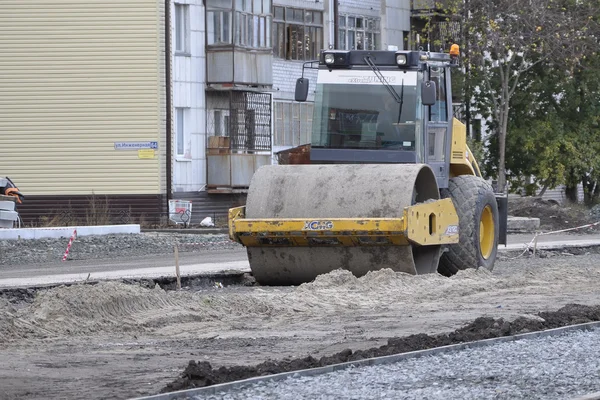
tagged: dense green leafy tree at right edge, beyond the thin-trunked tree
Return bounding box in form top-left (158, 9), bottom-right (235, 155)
top-left (506, 51), bottom-right (600, 203)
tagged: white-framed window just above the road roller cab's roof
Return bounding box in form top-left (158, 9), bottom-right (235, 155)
top-left (338, 15), bottom-right (381, 50)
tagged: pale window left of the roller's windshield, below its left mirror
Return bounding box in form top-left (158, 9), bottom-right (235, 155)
top-left (273, 101), bottom-right (313, 146)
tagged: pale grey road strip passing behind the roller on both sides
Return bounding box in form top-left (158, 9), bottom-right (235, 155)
top-left (0, 234), bottom-right (600, 287)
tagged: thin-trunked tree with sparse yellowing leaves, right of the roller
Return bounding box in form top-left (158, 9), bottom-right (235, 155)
top-left (463, 0), bottom-right (598, 191)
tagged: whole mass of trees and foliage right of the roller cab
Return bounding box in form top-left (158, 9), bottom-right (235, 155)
top-left (414, 0), bottom-right (600, 203)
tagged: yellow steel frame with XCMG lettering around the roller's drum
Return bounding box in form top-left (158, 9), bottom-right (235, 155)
top-left (229, 199), bottom-right (459, 247)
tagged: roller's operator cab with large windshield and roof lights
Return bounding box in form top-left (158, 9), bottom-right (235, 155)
top-left (296, 51), bottom-right (479, 188)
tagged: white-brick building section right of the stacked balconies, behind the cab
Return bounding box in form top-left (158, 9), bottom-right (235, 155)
top-left (273, 0), bottom-right (410, 155)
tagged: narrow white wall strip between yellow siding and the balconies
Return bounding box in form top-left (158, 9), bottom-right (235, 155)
top-left (171, 0), bottom-right (206, 192)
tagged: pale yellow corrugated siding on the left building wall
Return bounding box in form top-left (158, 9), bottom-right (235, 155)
top-left (0, 0), bottom-right (165, 195)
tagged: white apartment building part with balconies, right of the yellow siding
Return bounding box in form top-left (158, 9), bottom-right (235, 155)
top-left (172, 0), bottom-right (411, 220)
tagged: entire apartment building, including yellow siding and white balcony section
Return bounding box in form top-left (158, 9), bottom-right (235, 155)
top-left (0, 0), bottom-right (446, 222)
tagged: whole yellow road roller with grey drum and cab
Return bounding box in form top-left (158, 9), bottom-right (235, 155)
top-left (229, 46), bottom-right (507, 285)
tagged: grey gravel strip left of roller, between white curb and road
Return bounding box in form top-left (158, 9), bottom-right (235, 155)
top-left (0, 232), bottom-right (241, 265)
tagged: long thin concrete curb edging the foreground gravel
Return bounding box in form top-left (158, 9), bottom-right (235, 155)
top-left (134, 322), bottom-right (600, 400)
